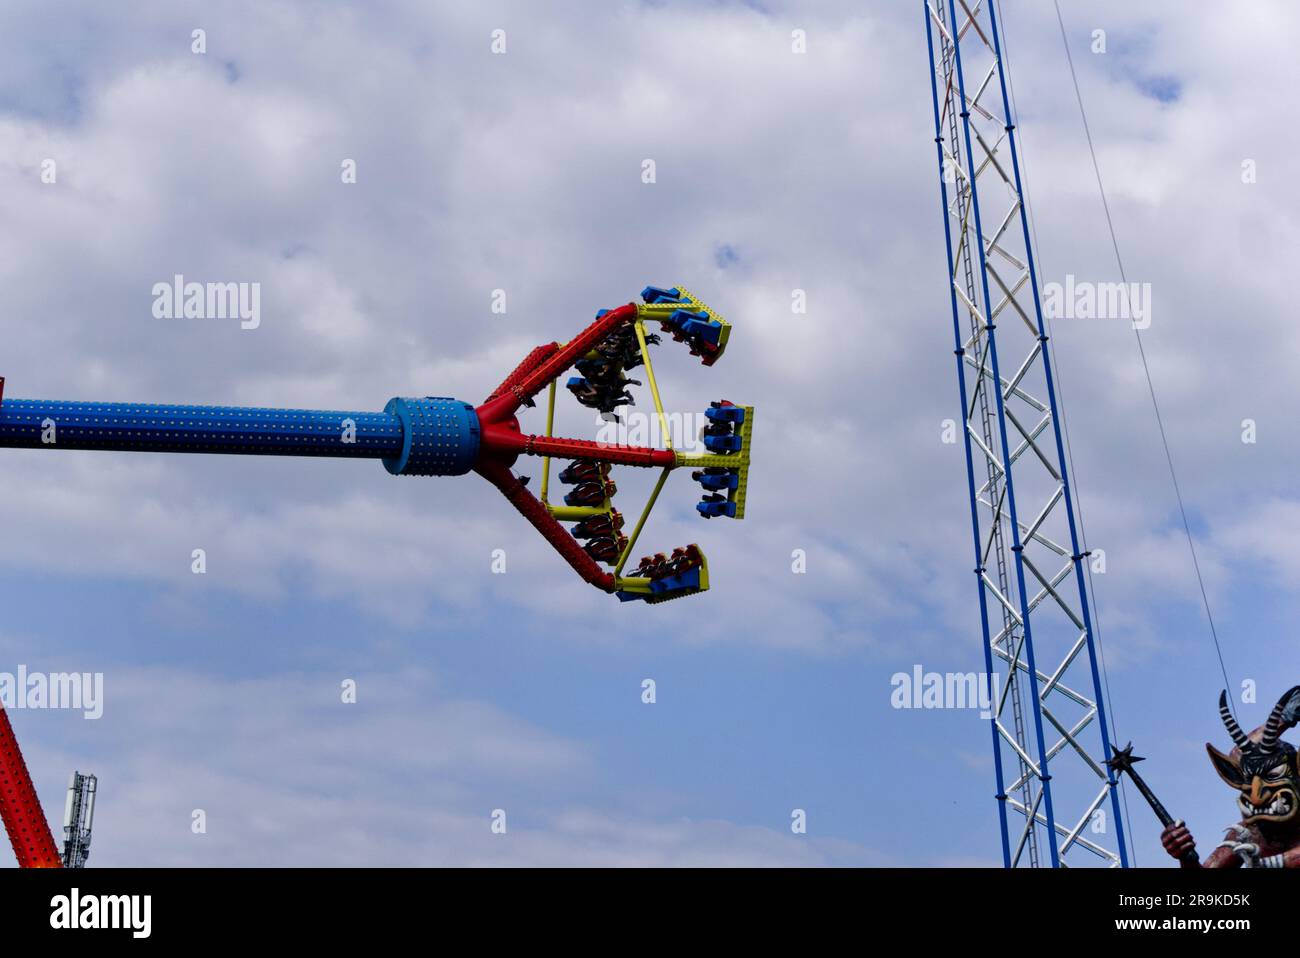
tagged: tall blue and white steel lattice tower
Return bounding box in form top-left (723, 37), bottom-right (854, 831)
top-left (923, 0), bottom-right (1128, 867)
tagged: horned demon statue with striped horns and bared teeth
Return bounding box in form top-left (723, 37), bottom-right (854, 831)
top-left (1160, 685), bottom-right (1300, 868)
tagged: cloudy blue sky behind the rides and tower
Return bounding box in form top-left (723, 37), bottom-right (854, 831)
top-left (0, 0), bottom-right (1300, 866)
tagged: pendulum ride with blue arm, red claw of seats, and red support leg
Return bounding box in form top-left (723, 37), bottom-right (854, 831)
top-left (0, 286), bottom-right (754, 867)
